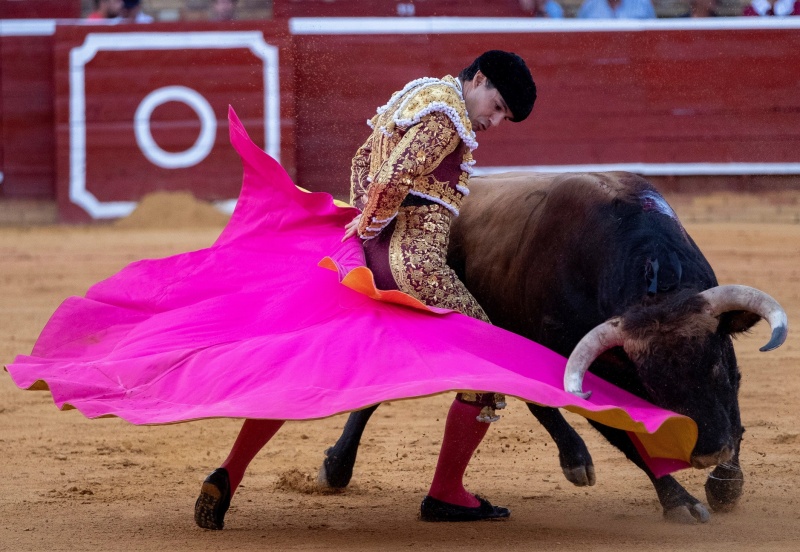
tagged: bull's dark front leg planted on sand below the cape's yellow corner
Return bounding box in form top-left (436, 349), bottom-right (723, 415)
top-left (589, 420), bottom-right (711, 523)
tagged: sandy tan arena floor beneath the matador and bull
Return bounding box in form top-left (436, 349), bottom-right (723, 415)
top-left (0, 194), bottom-right (800, 552)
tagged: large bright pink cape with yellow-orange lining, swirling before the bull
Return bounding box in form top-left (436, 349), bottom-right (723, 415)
top-left (6, 106), bottom-right (697, 475)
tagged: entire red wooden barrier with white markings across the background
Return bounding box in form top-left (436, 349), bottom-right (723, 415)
top-left (0, 17), bottom-right (800, 221)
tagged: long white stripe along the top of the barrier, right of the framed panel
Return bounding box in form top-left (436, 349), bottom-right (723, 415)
top-left (289, 17), bottom-right (800, 35)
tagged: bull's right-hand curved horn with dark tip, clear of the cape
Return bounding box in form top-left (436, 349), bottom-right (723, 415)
top-left (700, 285), bottom-right (789, 351)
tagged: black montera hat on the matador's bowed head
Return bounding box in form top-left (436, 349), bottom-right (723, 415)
top-left (478, 50), bottom-right (536, 123)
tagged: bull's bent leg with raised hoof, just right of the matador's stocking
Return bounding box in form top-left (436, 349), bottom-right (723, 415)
top-left (527, 403), bottom-right (595, 487)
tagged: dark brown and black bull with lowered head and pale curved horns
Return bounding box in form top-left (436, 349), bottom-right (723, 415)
top-left (320, 172), bottom-right (787, 523)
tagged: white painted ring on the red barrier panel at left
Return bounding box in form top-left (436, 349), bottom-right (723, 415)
top-left (133, 86), bottom-right (217, 169)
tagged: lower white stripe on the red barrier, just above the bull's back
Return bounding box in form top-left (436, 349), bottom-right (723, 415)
top-left (475, 163), bottom-right (800, 176)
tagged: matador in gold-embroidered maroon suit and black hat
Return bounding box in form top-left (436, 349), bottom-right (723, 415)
top-left (345, 50), bottom-right (536, 521)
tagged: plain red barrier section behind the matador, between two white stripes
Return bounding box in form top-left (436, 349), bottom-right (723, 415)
top-left (294, 25), bottom-right (800, 198)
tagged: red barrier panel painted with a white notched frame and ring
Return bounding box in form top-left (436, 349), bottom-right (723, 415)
top-left (55, 22), bottom-right (296, 221)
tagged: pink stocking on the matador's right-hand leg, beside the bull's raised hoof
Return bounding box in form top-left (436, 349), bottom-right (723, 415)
top-left (428, 400), bottom-right (489, 508)
